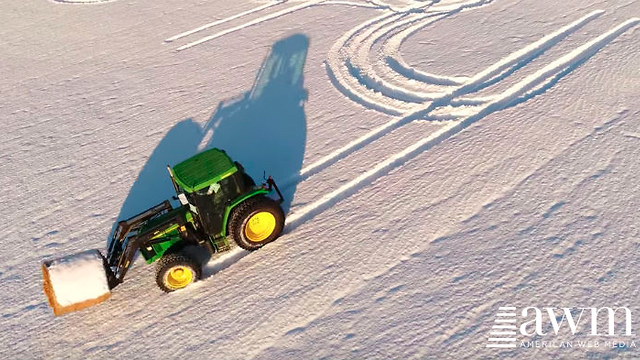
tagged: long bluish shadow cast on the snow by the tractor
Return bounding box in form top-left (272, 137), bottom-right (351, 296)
top-left (112, 34), bottom-right (309, 275)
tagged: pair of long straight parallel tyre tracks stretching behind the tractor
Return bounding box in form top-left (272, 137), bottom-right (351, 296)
top-left (287, 10), bottom-right (640, 229)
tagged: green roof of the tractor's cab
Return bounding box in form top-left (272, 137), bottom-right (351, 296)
top-left (171, 148), bottom-right (238, 192)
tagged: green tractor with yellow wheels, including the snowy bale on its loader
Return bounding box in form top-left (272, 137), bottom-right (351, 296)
top-left (43, 149), bottom-right (285, 314)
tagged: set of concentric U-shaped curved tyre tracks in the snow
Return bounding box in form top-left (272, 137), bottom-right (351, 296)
top-left (326, 0), bottom-right (491, 116)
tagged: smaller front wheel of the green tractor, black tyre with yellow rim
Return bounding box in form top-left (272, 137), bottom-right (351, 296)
top-left (156, 252), bottom-right (202, 292)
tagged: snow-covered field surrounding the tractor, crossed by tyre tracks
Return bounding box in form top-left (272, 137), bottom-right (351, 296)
top-left (0, 0), bottom-right (640, 359)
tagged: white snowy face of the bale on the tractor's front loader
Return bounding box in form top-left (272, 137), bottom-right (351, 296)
top-left (47, 250), bottom-right (109, 306)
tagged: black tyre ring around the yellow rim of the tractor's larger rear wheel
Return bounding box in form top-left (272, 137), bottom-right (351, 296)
top-left (229, 196), bottom-right (284, 251)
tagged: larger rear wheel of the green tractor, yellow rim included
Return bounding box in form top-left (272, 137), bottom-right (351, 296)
top-left (229, 196), bottom-right (284, 251)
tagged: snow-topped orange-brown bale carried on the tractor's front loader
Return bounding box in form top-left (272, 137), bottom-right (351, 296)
top-left (42, 250), bottom-right (111, 316)
